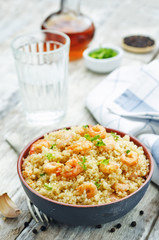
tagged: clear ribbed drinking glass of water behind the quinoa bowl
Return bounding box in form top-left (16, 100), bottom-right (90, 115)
top-left (11, 30), bottom-right (70, 125)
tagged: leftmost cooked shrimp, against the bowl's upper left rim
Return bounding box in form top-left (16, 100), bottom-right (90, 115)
top-left (29, 139), bottom-right (50, 154)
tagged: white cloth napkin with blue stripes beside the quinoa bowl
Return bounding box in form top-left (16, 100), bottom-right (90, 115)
top-left (86, 60), bottom-right (159, 185)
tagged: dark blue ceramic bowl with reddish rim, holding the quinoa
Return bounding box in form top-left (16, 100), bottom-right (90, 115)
top-left (17, 128), bottom-right (153, 226)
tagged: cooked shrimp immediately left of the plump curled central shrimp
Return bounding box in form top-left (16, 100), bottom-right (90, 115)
top-left (43, 162), bottom-right (63, 176)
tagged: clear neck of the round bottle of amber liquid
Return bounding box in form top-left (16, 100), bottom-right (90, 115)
top-left (61, 0), bottom-right (80, 15)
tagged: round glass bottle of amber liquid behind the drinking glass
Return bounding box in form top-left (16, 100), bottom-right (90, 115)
top-left (41, 0), bottom-right (95, 61)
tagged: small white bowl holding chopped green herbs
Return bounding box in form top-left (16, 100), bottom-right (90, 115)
top-left (83, 44), bottom-right (123, 73)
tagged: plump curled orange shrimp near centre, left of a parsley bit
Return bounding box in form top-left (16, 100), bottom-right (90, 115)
top-left (62, 158), bottom-right (83, 178)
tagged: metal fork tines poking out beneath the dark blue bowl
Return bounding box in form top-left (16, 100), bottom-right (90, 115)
top-left (26, 198), bottom-right (51, 227)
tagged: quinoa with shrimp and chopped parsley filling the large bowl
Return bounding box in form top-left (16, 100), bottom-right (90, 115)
top-left (22, 125), bottom-right (149, 205)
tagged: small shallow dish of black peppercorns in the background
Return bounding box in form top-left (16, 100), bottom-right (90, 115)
top-left (122, 35), bottom-right (155, 53)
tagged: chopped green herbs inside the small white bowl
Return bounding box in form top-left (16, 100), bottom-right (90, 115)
top-left (89, 48), bottom-right (118, 59)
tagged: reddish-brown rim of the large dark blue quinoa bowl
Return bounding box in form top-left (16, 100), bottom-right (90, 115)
top-left (17, 127), bottom-right (154, 208)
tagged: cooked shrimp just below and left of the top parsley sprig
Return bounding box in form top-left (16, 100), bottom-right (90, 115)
top-left (67, 141), bottom-right (93, 154)
